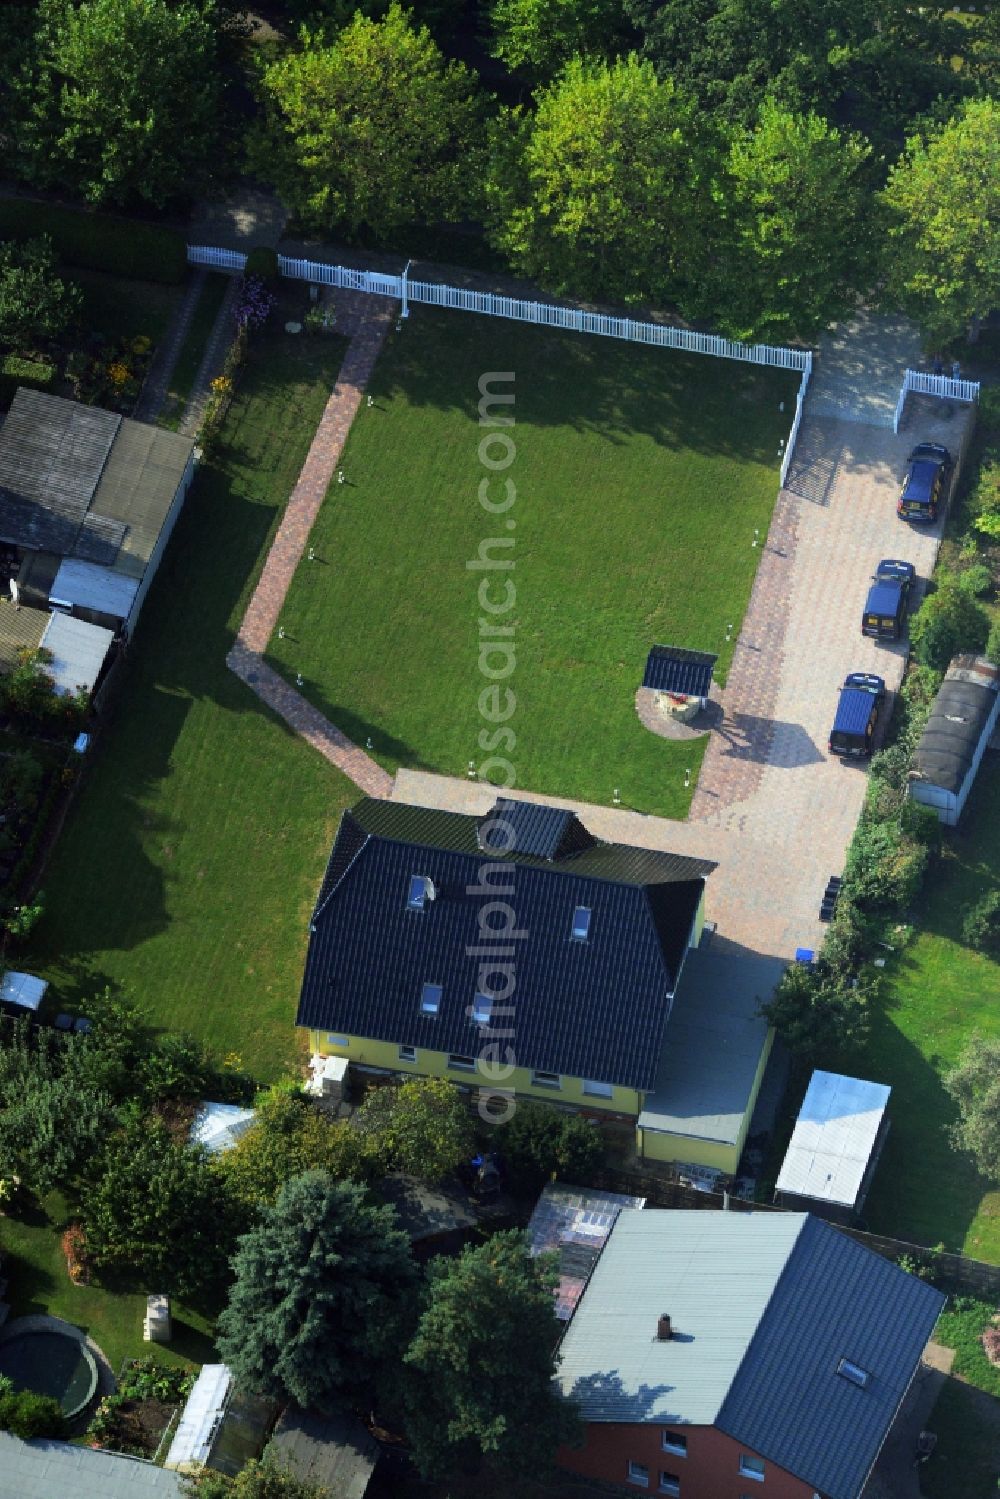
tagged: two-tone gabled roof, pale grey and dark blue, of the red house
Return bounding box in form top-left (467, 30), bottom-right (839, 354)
top-left (559, 1210), bottom-right (945, 1499)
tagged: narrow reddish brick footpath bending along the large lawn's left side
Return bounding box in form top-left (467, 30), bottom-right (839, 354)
top-left (226, 291), bottom-right (396, 796)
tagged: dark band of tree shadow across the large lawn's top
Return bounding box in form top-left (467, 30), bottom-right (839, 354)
top-left (370, 307), bottom-right (801, 461)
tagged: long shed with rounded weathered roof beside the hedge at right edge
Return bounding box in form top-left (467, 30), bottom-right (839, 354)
top-left (910, 655), bottom-right (1000, 827)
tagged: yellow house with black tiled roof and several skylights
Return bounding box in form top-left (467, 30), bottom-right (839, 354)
top-left (298, 797), bottom-right (763, 1171)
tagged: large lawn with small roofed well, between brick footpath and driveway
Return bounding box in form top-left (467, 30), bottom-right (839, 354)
top-left (270, 307), bottom-right (798, 817)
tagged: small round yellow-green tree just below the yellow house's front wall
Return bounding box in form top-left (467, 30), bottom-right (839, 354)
top-left (354, 1078), bottom-right (475, 1181)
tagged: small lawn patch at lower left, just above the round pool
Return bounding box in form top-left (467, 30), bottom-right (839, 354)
top-left (0, 1193), bottom-right (211, 1373)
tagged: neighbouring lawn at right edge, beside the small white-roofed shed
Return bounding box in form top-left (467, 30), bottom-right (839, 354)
top-left (855, 755), bottom-right (1000, 1264)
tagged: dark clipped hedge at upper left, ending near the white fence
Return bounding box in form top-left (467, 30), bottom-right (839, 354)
top-left (0, 198), bottom-right (187, 285)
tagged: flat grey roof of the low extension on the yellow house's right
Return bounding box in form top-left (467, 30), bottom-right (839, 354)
top-left (639, 934), bottom-right (786, 1145)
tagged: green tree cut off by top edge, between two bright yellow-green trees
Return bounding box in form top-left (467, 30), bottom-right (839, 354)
top-left (489, 0), bottom-right (628, 81)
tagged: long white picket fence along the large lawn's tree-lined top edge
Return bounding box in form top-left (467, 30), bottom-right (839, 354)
top-left (187, 244), bottom-right (813, 370)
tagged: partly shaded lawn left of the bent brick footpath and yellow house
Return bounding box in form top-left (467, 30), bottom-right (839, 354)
top-left (19, 313), bottom-right (354, 1079)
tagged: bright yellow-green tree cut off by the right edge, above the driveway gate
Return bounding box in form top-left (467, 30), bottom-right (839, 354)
top-left (883, 99), bottom-right (1000, 343)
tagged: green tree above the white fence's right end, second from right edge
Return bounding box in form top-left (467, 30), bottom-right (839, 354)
top-left (701, 103), bottom-right (871, 342)
